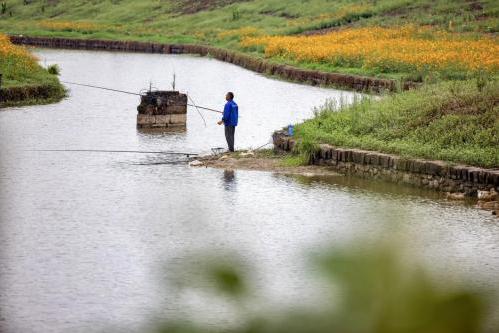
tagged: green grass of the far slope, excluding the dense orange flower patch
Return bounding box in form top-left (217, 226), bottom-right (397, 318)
top-left (0, 0), bottom-right (499, 80)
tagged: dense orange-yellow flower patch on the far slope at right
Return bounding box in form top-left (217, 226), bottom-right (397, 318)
top-left (241, 26), bottom-right (499, 72)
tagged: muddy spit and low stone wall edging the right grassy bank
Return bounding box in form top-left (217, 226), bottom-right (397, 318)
top-left (190, 149), bottom-right (499, 216)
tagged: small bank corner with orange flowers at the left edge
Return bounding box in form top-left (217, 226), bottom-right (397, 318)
top-left (0, 34), bottom-right (65, 106)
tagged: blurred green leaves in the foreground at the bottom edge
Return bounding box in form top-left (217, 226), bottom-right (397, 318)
top-left (157, 237), bottom-right (490, 333)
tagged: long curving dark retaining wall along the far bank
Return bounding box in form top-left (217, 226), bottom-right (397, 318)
top-left (10, 36), bottom-right (417, 92)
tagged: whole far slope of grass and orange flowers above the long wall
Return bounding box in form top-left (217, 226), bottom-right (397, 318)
top-left (0, 0), bottom-right (499, 81)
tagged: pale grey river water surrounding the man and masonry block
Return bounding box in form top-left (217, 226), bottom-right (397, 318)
top-left (0, 50), bottom-right (499, 332)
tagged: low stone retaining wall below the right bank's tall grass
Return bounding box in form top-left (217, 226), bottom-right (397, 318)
top-left (273, 131), bottom-right (499, 197)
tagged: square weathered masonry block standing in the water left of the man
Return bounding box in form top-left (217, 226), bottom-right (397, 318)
top-left (137, 91), bottom-right (187, 128)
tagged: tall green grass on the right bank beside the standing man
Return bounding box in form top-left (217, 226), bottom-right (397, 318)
top-left (296, 80), bottom-right (499, 167)
